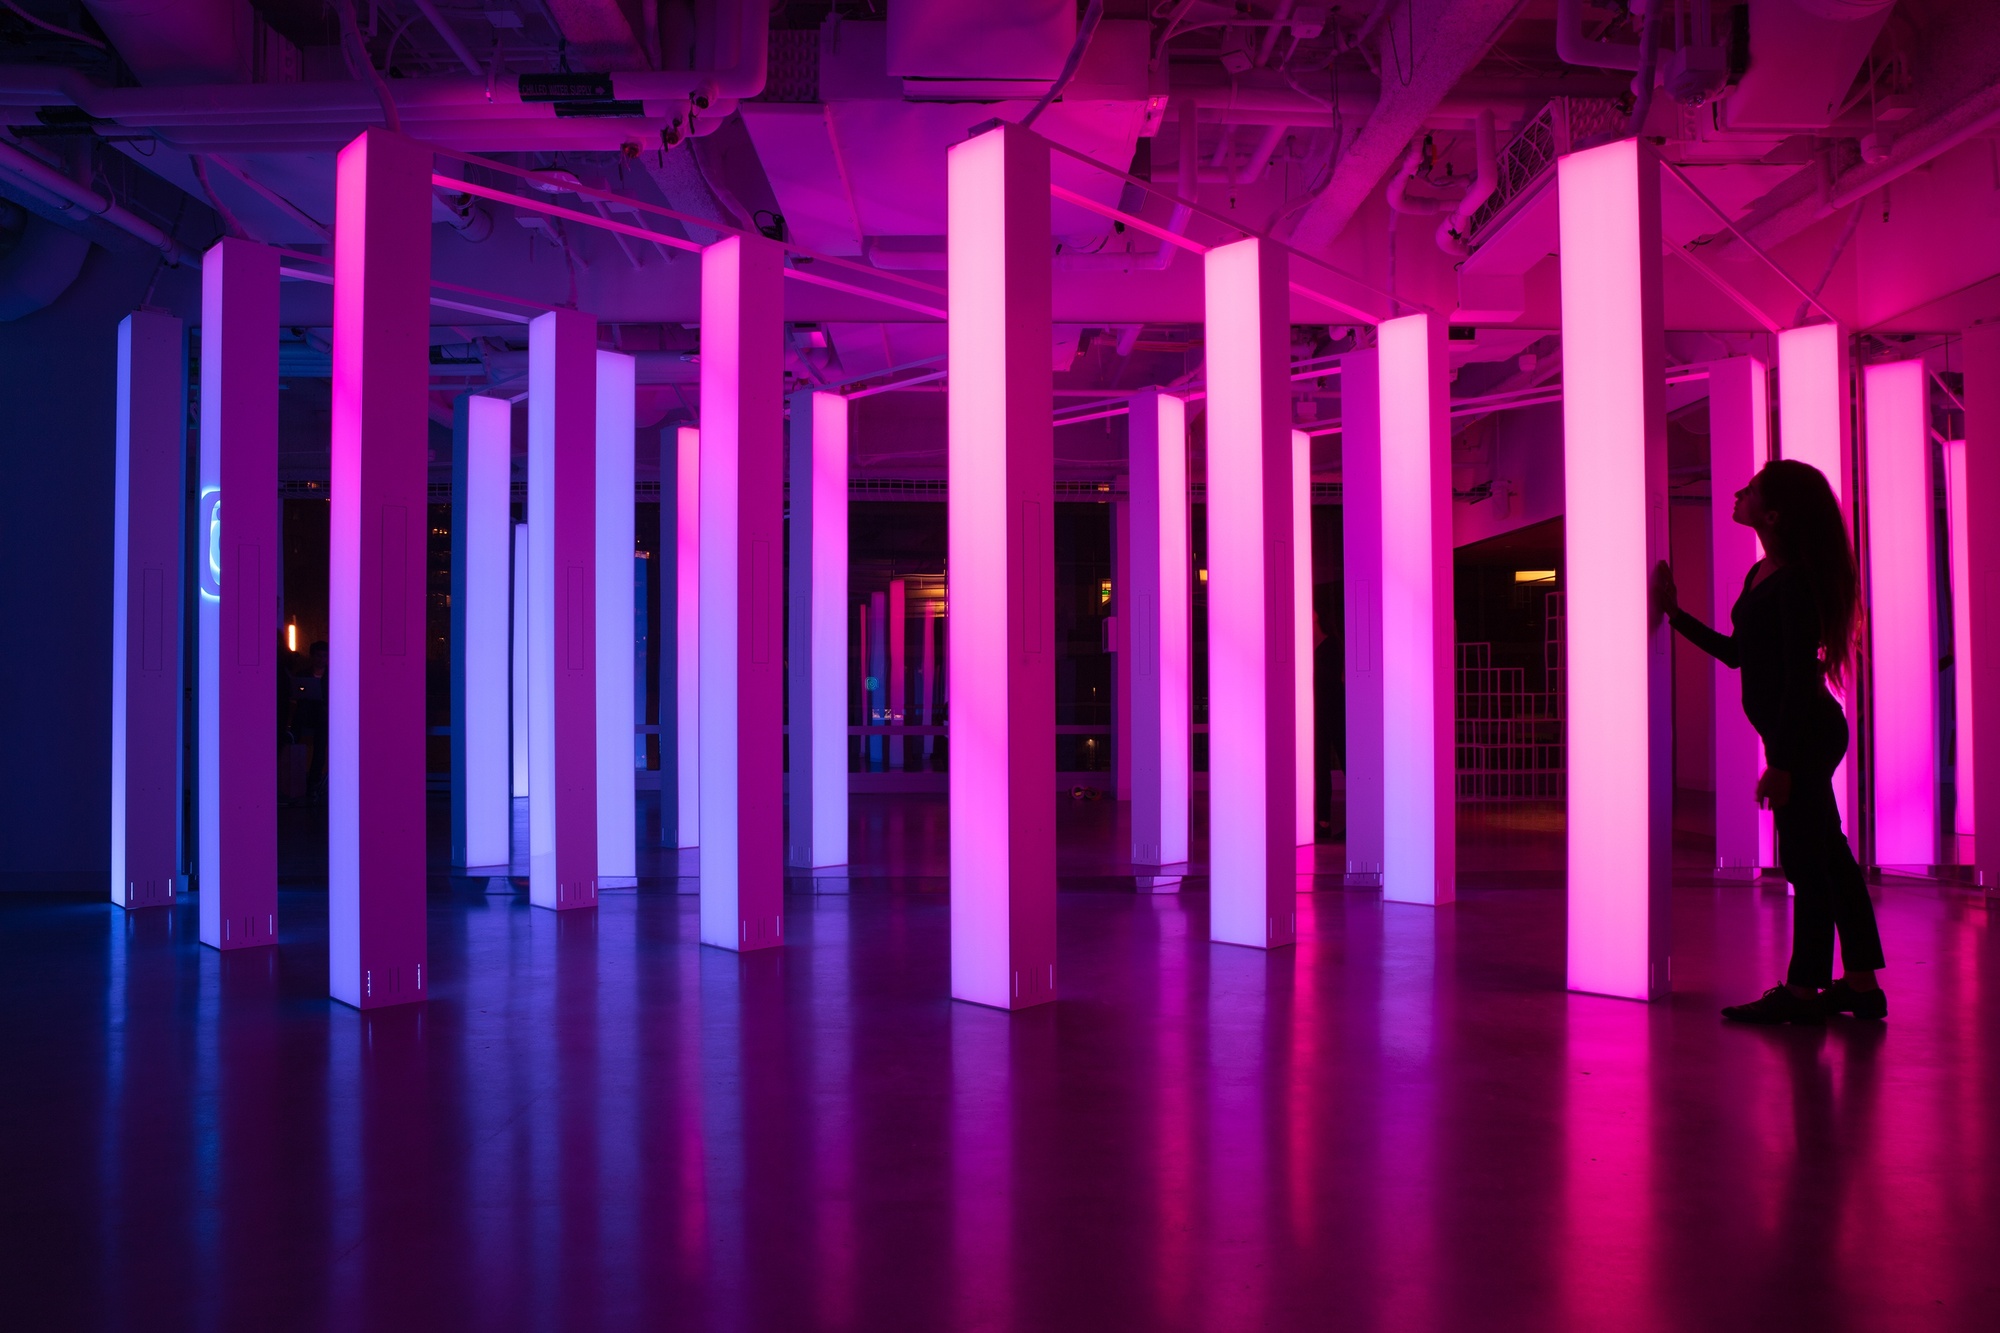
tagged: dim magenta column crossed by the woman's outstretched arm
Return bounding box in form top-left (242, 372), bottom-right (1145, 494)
top-left (1708, 356), bottom-right (1770, 879)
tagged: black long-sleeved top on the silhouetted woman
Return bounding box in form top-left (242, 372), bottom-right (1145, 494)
top-left (1672, 564), bottom-right (1842, 771)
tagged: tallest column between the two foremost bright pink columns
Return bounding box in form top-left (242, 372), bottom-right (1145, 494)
top-left (1204, 238), bottom-right (1298, 949)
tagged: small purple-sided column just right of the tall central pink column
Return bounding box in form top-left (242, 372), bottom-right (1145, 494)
top-left (1118, 388), bottom-right (1192, 872)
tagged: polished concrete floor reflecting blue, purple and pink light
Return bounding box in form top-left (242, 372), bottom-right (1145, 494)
top-left (0, 797), bottom-right (2000, 1333)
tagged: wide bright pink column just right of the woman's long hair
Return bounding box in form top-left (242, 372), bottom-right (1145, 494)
top-left (1862, 360), bottom-right (1940, 867)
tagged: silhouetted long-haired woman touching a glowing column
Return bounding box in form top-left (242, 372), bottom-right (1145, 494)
top-left (1654, 460), bottom-right (1888, 1023)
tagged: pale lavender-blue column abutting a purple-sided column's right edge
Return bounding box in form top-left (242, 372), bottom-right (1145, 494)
top-left (596, 352), bottom-right (638, 887)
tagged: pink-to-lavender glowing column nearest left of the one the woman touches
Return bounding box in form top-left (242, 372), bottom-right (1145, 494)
top-left (1376, 314), bottom-right (1458, 907)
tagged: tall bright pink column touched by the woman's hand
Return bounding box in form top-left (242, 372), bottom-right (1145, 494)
top-left (1560, 140), bottom-right (1674, 999)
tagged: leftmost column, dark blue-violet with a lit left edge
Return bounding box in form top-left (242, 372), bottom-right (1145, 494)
top-left (112, 310), bottom-right (185, 907)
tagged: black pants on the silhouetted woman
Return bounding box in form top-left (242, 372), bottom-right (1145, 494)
top-left (1776, 713), bottom-right (1882, 987)
